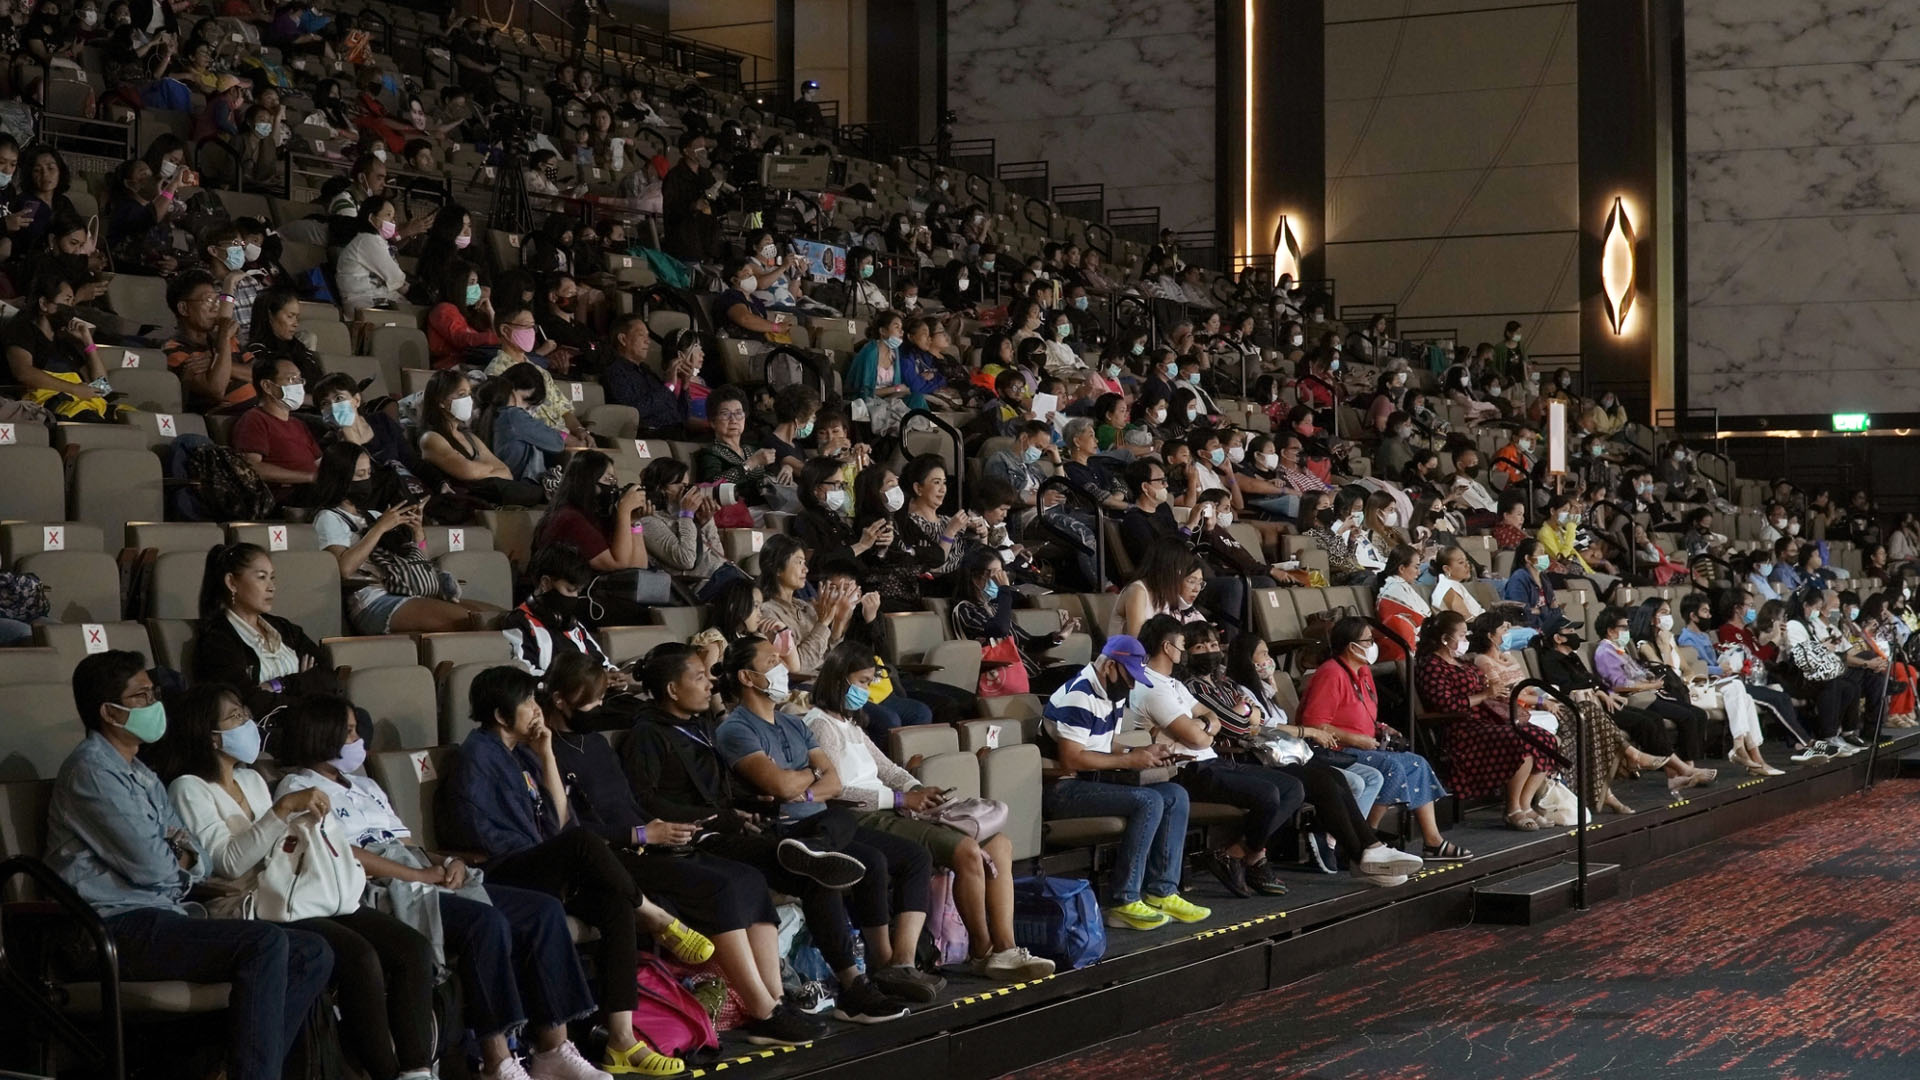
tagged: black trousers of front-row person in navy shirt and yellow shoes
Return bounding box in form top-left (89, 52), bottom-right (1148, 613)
top-left (486, 828), bottom-right (641, 1013)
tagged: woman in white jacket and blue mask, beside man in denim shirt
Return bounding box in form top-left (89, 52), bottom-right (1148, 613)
top-left (142, 684), bottom-right (434, 1080)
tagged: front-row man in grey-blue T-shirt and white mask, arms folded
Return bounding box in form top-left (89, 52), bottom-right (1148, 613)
top-left (714, 634), bottom-right (945, 999)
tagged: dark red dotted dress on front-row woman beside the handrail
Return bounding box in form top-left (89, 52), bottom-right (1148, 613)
top-left (1413, 655), bottom-right (1561, 799)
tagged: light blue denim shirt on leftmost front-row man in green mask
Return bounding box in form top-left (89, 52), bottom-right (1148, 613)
top-left (46, 732), bottom-right (207, 915)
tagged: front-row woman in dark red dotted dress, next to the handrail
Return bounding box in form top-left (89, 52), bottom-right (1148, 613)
top-left (1413, 611), bottom-right (1559, 832)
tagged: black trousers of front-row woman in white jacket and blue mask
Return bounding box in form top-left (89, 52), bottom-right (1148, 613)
top-left (290, 907), bottom-right (434, 1080)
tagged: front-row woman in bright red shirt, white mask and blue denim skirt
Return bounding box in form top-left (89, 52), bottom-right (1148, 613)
top-left (1298, 615), bottom-right (1473, 861)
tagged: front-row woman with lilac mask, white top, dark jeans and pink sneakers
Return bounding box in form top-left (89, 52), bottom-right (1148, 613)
top-left (273, 698), bottom-right (607, 1080)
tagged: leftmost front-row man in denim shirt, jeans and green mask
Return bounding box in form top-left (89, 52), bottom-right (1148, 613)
top-left (46, 650), bottom-right (334, 1080)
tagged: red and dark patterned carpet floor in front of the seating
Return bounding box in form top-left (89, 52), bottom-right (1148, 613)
top-left (1014, 780), bottom-right (1920, 1080)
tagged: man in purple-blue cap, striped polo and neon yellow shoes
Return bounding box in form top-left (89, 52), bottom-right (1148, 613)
top-left (1041, 634), bottom-right (1212, 930)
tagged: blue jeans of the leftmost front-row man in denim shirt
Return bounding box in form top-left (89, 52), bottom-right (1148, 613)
top-left (106, 907), bottom-right (334, 1080)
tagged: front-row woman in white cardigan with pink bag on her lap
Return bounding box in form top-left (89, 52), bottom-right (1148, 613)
top-left (806, 642), bottom-right (1054, 982)
